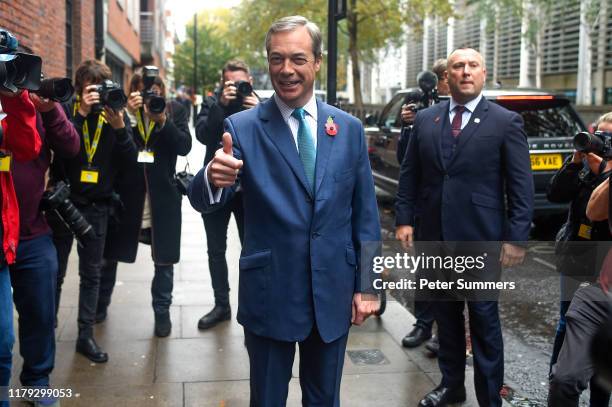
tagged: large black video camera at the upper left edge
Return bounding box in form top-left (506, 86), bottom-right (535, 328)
top-left (0, 28), bottom-right (42, 92)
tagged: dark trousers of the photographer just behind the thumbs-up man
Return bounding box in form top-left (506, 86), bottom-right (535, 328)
top-left (202, 192), bottom-right (244, 305)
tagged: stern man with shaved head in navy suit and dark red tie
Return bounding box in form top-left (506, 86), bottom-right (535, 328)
top-left (396, 48), bottom-right (533, 407)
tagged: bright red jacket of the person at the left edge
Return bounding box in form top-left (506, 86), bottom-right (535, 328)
top-left (0, 91), bottom-right (41, 264)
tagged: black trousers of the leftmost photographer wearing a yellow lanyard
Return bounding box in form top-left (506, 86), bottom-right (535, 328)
top-left (53, 203), bottom-right (108, 337)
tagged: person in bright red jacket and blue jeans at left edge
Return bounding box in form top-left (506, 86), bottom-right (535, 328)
top-left (0, 90), bottom-right (41, 407)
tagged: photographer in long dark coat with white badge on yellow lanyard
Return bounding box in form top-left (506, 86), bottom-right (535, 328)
top-left (97, 68), bottom-right (191, 337)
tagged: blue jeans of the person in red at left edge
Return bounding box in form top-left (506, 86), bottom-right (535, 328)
top-left (0, 265), bottom-right (15, 407)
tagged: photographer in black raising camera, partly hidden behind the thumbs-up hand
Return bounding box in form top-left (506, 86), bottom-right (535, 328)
top-left (196, 60), bottom-right (259, 329)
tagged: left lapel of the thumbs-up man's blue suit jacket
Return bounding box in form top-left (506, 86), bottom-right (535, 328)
top-left (259, 97), bottom-right (318, 198)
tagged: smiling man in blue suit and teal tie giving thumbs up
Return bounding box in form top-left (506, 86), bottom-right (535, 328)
top-left (189, 16), bottom-right (380, 407)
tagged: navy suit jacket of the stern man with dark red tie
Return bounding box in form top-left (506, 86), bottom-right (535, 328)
top-left (396, 97), bottom-right (534, 242)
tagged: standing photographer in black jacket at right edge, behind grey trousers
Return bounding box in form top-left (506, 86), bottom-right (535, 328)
top-left (547, 113), bottom-right (612, 406)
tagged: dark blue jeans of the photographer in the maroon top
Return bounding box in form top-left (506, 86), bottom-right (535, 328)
top-left (10, 235), bottom-right (57, 386)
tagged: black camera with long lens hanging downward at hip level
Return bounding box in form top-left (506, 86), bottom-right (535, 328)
top-left (40, 181), bottom-right (96, 244)
